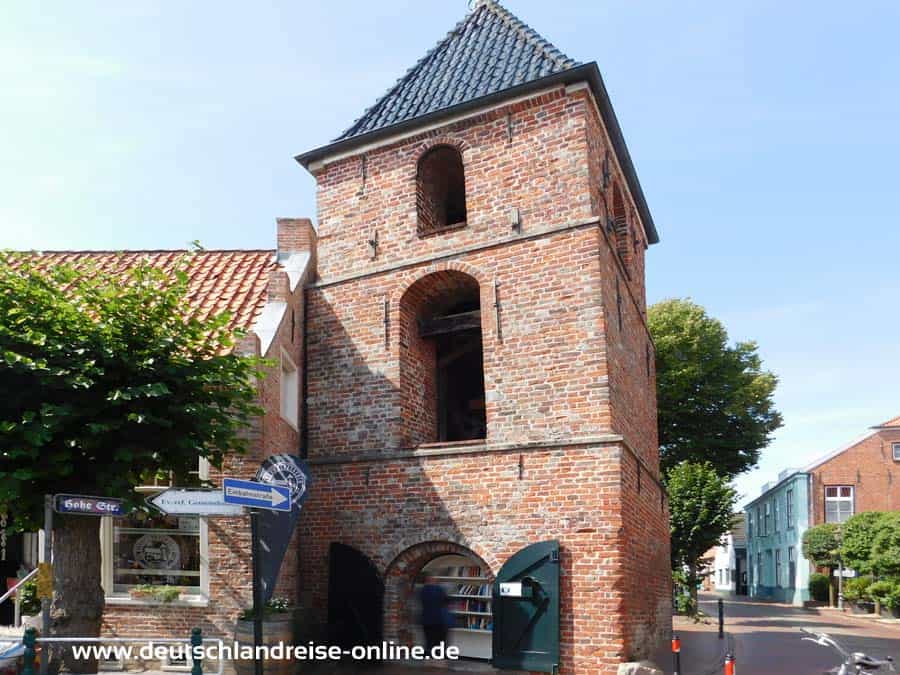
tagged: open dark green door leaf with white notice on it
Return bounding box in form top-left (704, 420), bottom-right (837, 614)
top-left (492, 541), bottom-right (559, 673)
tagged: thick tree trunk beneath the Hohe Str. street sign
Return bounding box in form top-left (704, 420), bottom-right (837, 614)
top-left (50, 515), bottom-right (103, 673)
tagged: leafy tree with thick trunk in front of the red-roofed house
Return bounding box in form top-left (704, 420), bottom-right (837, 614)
top-left (0, 253), bottom-right (261, 672)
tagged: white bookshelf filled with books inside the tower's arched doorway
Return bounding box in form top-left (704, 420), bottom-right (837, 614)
top-left (420, 555), bottom-right (493, 659)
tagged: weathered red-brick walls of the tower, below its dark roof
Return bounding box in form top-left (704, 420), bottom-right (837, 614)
top-left (301, 88), bottom-right (671, 673)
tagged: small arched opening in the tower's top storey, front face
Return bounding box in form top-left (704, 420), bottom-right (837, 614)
top-left (416, 145), bottom-right (467, 234)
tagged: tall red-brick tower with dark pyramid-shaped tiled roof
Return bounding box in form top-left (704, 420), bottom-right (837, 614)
top-left (297, 0), bottom-right (671, 674)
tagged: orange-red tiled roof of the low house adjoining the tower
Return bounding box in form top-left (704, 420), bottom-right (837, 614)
top-left (7, 250), bottom-right (278, 330)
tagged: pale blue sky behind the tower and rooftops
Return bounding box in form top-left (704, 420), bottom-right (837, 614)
top-left (0, 0), bottom-right (900, 502)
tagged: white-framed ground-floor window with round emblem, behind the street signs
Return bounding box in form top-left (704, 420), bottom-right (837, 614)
top-left (100, 459), bottom-right (209, 599)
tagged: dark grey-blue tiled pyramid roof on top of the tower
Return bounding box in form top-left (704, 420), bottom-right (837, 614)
top-left (335, 0), bottom-right (580, 141)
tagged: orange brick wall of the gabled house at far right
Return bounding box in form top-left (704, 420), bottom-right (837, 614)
top-left (810, 427), bottom-right (900, 525)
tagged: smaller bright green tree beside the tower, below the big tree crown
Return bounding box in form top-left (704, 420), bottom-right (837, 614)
top-left (666, 462), bottom-right (737, 612)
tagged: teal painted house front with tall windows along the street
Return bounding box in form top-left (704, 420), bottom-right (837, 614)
top-left (744, 469), bottom-right (810, 605)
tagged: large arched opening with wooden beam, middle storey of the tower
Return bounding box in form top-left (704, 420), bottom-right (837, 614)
top-left (400, 271), bottom-right (487, 446)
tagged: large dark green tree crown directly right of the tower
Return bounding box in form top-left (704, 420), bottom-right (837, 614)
top-left (647, 300), bottom-right (782, 478)
